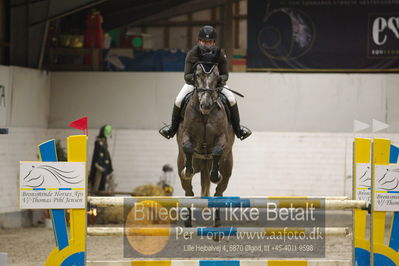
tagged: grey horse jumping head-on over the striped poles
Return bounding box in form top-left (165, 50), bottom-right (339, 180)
top-left (177, 64), bottom-right (235, 226)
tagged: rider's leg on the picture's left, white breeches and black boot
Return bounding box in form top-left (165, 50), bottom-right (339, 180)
top-left (159, 84), bottom-right (194, 139)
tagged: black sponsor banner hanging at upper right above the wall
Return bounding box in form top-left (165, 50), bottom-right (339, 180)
top-left (247, 0), bottom-right (399, 72)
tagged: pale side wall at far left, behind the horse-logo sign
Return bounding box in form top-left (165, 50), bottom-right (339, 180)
top-left (0, 67), bottom-right (50, 227)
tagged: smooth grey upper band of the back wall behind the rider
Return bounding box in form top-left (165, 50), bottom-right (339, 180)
top-left (49, 72), bottom-right (399, 133)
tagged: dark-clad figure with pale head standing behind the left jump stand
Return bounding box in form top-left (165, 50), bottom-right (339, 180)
top-left (89, 125), bottom-right (114, 194)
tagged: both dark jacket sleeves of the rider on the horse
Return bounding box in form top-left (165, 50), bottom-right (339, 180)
top-left (184, 44), bottom-right (229, 87)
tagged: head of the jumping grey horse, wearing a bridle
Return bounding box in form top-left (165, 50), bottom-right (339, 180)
top-left (194, 64), bottom-right (219, 115)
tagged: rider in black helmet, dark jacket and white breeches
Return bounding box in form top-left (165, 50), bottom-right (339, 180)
top-left (159, 26), bottom-right (252, 140)
